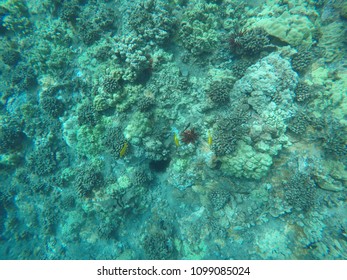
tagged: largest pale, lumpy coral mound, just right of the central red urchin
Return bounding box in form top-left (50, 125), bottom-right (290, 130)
top-left (217, 53), bottom-right (298, 179)
